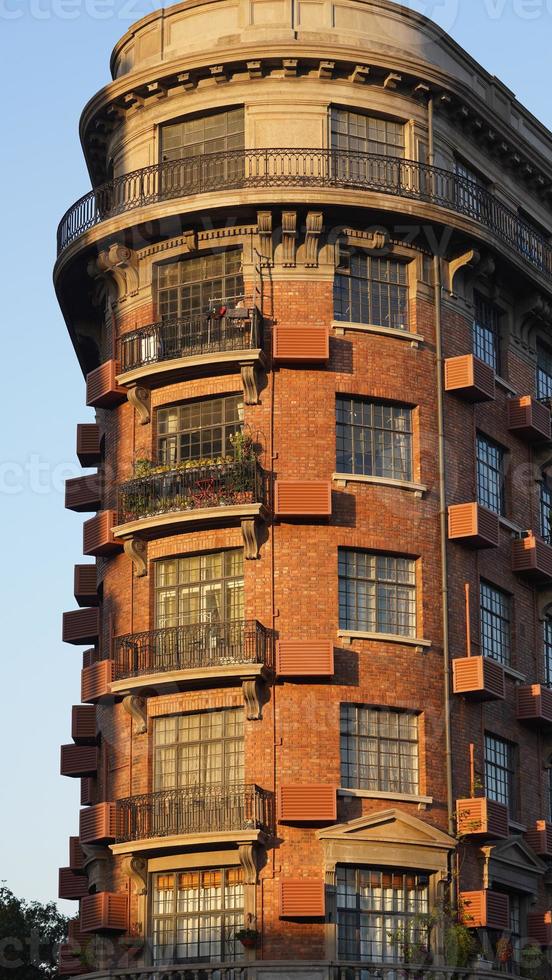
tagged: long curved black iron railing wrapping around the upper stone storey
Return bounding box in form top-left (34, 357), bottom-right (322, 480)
top-left (57, 148), bottom-right (552, 284)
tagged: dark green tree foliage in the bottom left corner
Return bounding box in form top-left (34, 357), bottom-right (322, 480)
top-left (0, 884), bottom-right (69, 980)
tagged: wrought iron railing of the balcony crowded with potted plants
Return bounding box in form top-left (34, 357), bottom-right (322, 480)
top-left (118, 460), bottom-right (266, 524)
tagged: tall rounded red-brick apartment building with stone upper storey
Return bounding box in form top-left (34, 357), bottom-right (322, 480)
top-left (55, 0), bottom-right (552, 980)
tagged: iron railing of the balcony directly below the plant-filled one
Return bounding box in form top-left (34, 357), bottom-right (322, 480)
top-left (113, 619), bottom-right (272, 680)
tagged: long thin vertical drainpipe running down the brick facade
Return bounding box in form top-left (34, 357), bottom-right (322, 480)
top-left (433, 255), bottom-right (455, 836)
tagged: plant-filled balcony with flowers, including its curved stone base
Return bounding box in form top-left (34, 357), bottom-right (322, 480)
top-left (113, 459), bottom-right (267, 558)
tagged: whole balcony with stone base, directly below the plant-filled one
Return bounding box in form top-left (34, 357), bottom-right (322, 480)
top-left (111, 620), bottom-right (273, 694)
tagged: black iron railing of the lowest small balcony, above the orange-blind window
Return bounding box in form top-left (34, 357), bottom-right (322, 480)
top-left (117, 784), bottom-right (274, 843)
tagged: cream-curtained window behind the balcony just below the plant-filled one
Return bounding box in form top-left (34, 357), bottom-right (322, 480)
top-left (155, 548), bottom-right (244, 629)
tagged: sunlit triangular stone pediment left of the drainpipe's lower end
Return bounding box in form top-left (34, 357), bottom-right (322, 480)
top-left (318, 809), bottom-right (456, 850)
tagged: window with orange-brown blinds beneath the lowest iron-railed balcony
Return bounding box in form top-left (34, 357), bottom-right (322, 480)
top-left (153, 868), bottom-right (244, 965)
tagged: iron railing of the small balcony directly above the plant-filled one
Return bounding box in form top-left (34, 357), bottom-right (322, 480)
top-left (119, 307), bottom-right (263, 373)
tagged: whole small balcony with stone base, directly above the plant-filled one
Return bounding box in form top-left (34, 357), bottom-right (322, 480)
top-left (118, 304), bottom-right (264, 396)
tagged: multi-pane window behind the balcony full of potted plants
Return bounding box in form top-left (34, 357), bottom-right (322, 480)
top-left (157, 395), bottom-right (243, 463)
